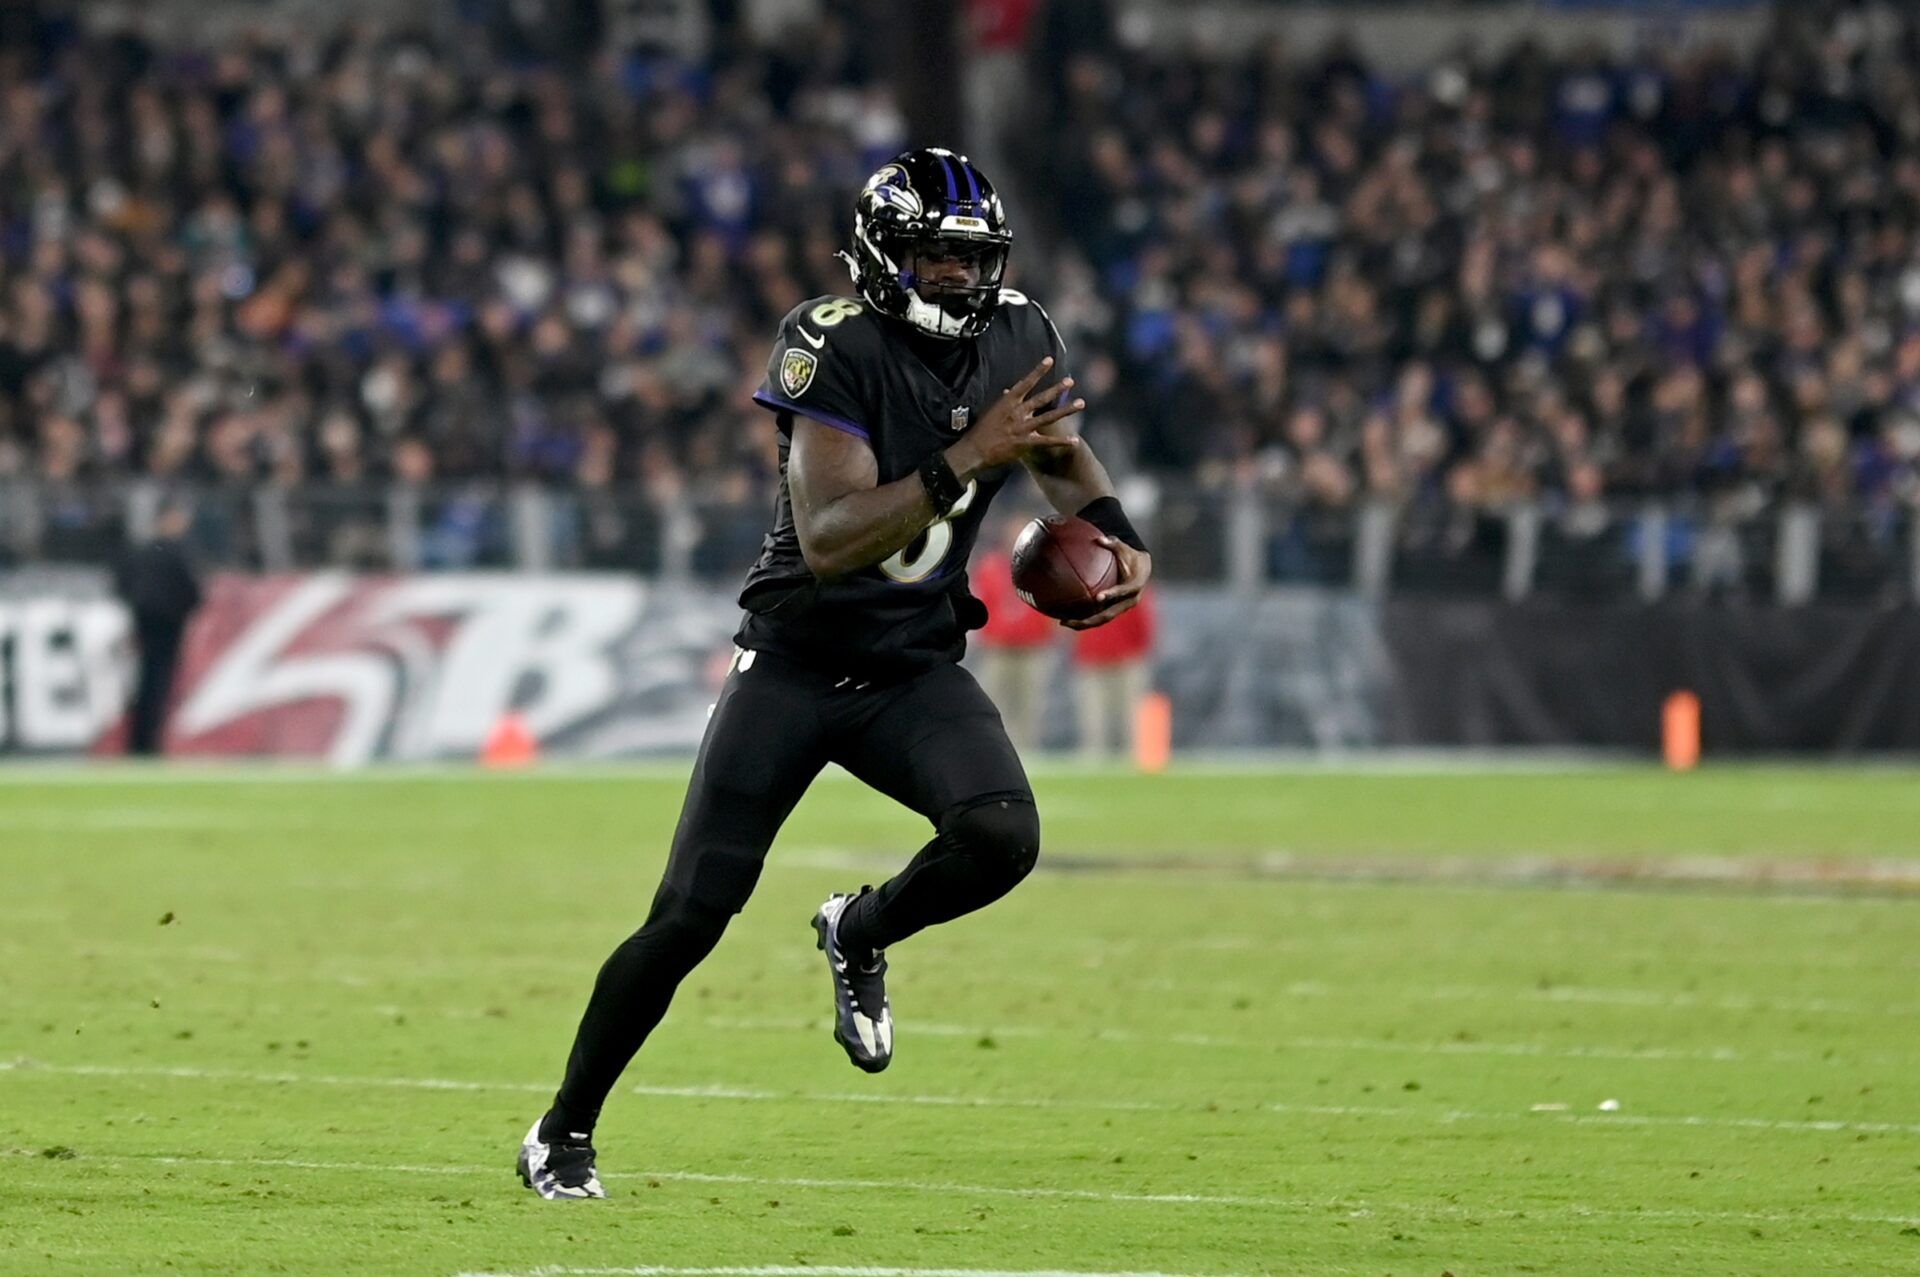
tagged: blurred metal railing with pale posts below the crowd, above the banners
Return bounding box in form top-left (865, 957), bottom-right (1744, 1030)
top-left (0, 478), bottom-right (1920, 605)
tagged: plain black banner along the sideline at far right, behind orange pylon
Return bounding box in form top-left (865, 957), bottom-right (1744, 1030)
top-left (1380, 599), bottom-right (1920, 753)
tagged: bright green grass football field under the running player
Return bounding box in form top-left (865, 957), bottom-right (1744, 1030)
top-left (0, 768), bottom-right (1920, 1277)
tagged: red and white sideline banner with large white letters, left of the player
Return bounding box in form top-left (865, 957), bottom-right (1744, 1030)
top-left (167, 572), bottom-right (739, 766)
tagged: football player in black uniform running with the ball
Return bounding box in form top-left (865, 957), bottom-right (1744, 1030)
top-left (518, 148), bottom-right (1152, 1198)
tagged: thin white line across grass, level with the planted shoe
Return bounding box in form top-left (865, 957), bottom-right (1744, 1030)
top-left (0, 1148), bottom-right (1920, 1228)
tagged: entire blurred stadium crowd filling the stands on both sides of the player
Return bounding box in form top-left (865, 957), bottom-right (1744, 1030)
top-left (0, 4), bottom-right (1920, 583)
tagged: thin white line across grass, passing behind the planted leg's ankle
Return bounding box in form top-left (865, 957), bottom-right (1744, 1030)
top-left (15, 1060), bottom-right (1920, 1136)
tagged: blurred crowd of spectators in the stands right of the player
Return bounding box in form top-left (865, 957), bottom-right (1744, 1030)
top-left (1029, 4), bottom-right (1920, 541)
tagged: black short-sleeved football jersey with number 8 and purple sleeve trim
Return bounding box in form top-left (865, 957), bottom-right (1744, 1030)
top-left (737, 288), bottom-right (1066, 678)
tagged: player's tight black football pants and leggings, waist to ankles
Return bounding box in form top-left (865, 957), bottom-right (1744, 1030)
top-left (547, 653), bottom-right (1041, 1135)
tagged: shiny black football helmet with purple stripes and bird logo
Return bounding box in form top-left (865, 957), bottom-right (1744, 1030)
top-left (841, 146), bottom-right (1014, 340)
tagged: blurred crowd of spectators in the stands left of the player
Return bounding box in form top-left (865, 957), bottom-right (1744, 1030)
top-left (0, 0), bottom-right (906, 506)
